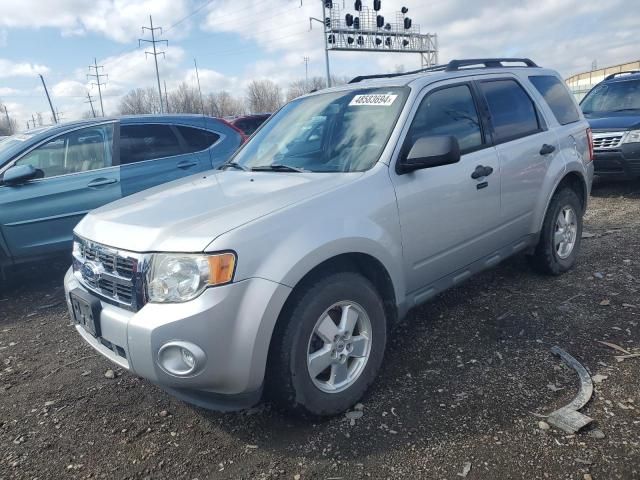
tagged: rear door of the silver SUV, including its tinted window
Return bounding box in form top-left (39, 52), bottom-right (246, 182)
top-left (478, 76), bottom-right (559, 240)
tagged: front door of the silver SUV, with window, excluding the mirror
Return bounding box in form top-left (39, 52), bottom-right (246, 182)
top-left (392, 83), bottom-right (500, 297)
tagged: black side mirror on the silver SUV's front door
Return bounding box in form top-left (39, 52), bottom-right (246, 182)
top-left (397, 135), bottom-right (460, 174)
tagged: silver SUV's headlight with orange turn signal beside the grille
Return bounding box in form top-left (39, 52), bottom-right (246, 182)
top-left (147, 253), bottom-right (236, 303)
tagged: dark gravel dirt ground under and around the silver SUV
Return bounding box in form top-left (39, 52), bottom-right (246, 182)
top-left (0, 177), bottom-right (640, 480)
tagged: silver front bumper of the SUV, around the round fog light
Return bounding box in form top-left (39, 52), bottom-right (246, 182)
top-left (64, 269), bottom-right (291, 410)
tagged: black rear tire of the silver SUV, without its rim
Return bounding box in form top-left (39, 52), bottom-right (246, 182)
top-left (529, 188), bottom-right (584, 275)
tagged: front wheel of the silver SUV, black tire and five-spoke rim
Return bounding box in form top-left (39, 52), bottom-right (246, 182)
top-left (267, 272), bottom-right (387, 415)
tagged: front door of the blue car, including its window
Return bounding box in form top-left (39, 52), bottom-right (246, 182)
top-left (0, 122), bottom-right (121, 261)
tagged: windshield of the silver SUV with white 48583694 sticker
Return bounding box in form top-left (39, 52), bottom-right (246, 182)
top-left (230, 87), bottom-right (409, 172)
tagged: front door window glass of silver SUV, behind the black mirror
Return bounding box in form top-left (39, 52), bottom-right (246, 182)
top-left (407, 85), bottom-right (482, 153)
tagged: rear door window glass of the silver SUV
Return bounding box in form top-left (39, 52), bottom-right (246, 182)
top-left (480, 80), bottom-right (540, 143)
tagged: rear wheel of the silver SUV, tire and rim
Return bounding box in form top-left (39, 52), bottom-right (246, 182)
top-left (530, 188), bottom-right (584, 275)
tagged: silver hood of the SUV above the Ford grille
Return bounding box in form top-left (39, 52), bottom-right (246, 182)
top-left (74, 170), bottom-right (362, 252)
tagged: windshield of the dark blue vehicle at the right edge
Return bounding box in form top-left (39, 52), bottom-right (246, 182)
top-left (580, 80), bottom-right (640, 113)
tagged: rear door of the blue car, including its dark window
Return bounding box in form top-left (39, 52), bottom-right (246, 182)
top-left (119, 123), bottom-right (211, 200)
